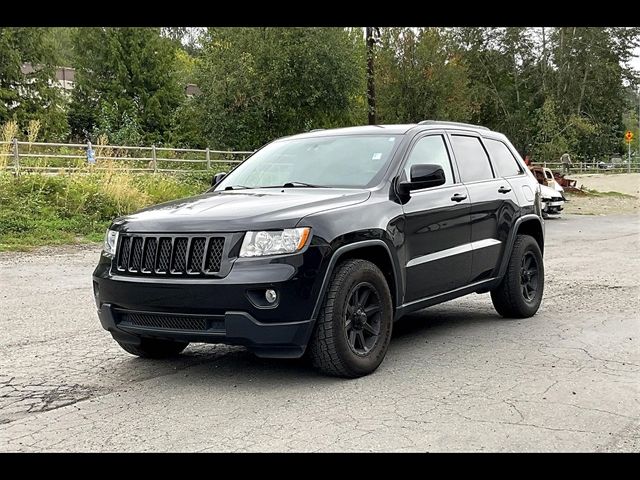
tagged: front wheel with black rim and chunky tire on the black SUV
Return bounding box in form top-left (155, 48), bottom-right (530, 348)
top-left (308, 259), bottom-right (393, 378)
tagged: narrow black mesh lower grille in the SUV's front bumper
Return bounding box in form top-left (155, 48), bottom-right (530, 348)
top-left (117, 312), bottom-right (224, 331)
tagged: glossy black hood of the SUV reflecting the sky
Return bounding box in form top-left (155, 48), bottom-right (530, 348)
top-left (114, 188), bottom-right (370, 232)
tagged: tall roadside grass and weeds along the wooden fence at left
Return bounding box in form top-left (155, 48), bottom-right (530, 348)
top-left (0, 168), bottom-right (218, 251)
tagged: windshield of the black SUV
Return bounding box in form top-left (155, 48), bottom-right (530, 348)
top-left (215, 135), bottom-right (397, 191)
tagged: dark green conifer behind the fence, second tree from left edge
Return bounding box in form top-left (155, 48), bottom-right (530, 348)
top-left (69, 27), bottom-right (185, 143)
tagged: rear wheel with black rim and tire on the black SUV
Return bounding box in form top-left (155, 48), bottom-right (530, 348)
top-left (491, 235), bottom-right (544, 318)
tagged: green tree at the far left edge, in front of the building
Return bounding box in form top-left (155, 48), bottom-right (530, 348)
top-left (0, 27), bottom-right (68, 141)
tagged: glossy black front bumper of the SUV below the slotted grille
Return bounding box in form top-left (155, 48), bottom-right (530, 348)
top-left (93, 247), bottom-right (326, 358)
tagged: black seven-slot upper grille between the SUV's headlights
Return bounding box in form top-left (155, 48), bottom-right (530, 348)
top-left (116, 234), bottom-right (224, 276)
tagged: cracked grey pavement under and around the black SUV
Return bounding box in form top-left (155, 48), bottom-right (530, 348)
top-left (0, 215), bottom-right (640, 452)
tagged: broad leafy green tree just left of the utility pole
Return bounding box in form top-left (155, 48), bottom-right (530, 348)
top-left (196, 28), bottom-right (364, 149)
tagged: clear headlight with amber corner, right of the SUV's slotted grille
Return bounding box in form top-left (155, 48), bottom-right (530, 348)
top-left (240, 227), bottom-right (311, 257)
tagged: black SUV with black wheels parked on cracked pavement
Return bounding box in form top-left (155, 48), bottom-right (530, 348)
top-left (93, 121), bottom-right (544, 377)
